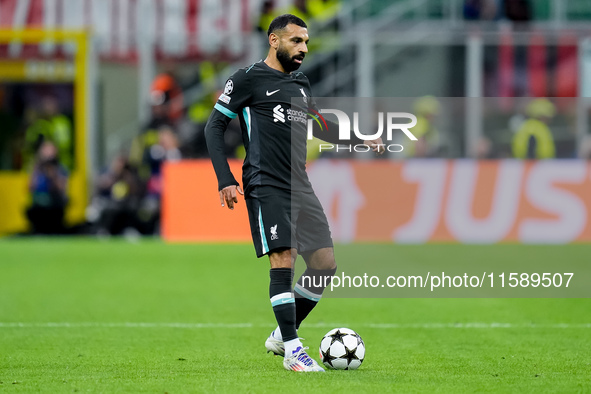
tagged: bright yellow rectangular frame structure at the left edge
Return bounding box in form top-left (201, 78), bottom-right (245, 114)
top-left (0, 30), bottom-right (89, 235)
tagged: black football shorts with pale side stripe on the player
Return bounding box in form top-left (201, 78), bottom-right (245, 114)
top-left (245, 186), bottom-right (333, 257)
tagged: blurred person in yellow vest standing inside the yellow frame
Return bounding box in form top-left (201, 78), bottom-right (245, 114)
top-left (25, 96), bottom-right (74, 170)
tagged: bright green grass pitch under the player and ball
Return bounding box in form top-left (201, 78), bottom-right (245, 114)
top-left (0, 238), bottom-right (591, 393)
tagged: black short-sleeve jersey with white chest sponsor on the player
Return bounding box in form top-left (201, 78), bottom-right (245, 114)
top-left (214, 60), bottom-right (315, 194)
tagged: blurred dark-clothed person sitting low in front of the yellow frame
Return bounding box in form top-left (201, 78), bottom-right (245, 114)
top-left (27, 141), bottom-right (68, 234)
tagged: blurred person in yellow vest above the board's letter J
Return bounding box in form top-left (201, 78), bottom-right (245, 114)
top-left (406, 96), bottom-right (441, 157)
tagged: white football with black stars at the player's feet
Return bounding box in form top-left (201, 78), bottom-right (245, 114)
top-left (320, 328), bottom-right (365, 369)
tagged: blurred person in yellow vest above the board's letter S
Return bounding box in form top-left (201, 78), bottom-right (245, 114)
top-left (512, 99), bottom-right (556, 159)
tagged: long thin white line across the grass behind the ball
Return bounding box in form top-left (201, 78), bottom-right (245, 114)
top-left (0, 322), bottom-right (591, 329)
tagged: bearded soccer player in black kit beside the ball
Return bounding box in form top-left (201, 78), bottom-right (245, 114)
top-left (205, 14), bottom-right (384, 372)
